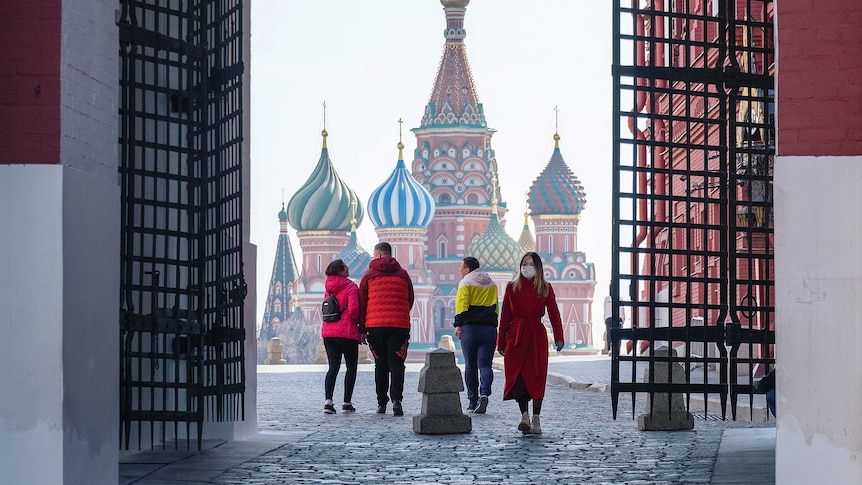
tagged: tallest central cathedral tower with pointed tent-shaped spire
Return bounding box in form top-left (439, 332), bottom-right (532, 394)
top-left (412, 0), bottom-right (506, 331)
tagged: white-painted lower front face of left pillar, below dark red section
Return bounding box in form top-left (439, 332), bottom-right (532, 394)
top-left (0, 165), bottom-right (63, 483)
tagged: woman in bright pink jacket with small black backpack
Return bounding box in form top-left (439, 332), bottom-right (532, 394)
top-left (320, 259), bottom-right (365, 414)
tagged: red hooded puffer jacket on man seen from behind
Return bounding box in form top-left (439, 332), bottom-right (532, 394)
top-left (359, 257), bottom-right (413, 329)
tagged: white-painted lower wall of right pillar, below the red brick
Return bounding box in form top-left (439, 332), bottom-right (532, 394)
top-left (775, 156), bottom-right (862, 484)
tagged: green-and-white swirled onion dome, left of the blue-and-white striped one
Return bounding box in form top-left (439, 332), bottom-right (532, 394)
top-left (287, 129), bottom-right (364, 232)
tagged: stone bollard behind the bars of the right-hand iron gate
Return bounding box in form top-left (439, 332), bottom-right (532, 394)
top-left (638, 349), bottom-right (694, 431)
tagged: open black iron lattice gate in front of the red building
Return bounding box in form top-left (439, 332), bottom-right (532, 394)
top-left (608, 0), bottom-right (775, 419)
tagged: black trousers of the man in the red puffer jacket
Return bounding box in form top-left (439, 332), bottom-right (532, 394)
top-left (368, 327), bottom-right (410, 406)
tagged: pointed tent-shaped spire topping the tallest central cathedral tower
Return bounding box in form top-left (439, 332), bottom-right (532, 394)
top-left (420, 0), bottom-right (487, 128)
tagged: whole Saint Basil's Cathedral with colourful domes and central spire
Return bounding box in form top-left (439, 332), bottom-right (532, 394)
top-left (260, 0), bottom-right (596, 351)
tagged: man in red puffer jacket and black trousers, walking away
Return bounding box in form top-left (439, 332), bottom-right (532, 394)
top-left (359, 242), bottom-right (413, 416)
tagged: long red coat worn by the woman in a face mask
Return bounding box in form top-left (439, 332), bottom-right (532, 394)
top-left (497, 276), bottom-right (563, 400)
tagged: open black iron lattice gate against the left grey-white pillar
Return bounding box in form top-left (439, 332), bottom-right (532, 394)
top-left (118, 0), bottom-right (246, 449)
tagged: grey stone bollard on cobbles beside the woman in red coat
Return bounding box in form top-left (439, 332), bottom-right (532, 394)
top-left (413, 349), bottom-right (473, 434)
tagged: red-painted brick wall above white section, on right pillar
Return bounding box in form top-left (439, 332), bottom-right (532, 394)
top-left (776, 0), bottom-right (862, 156)
